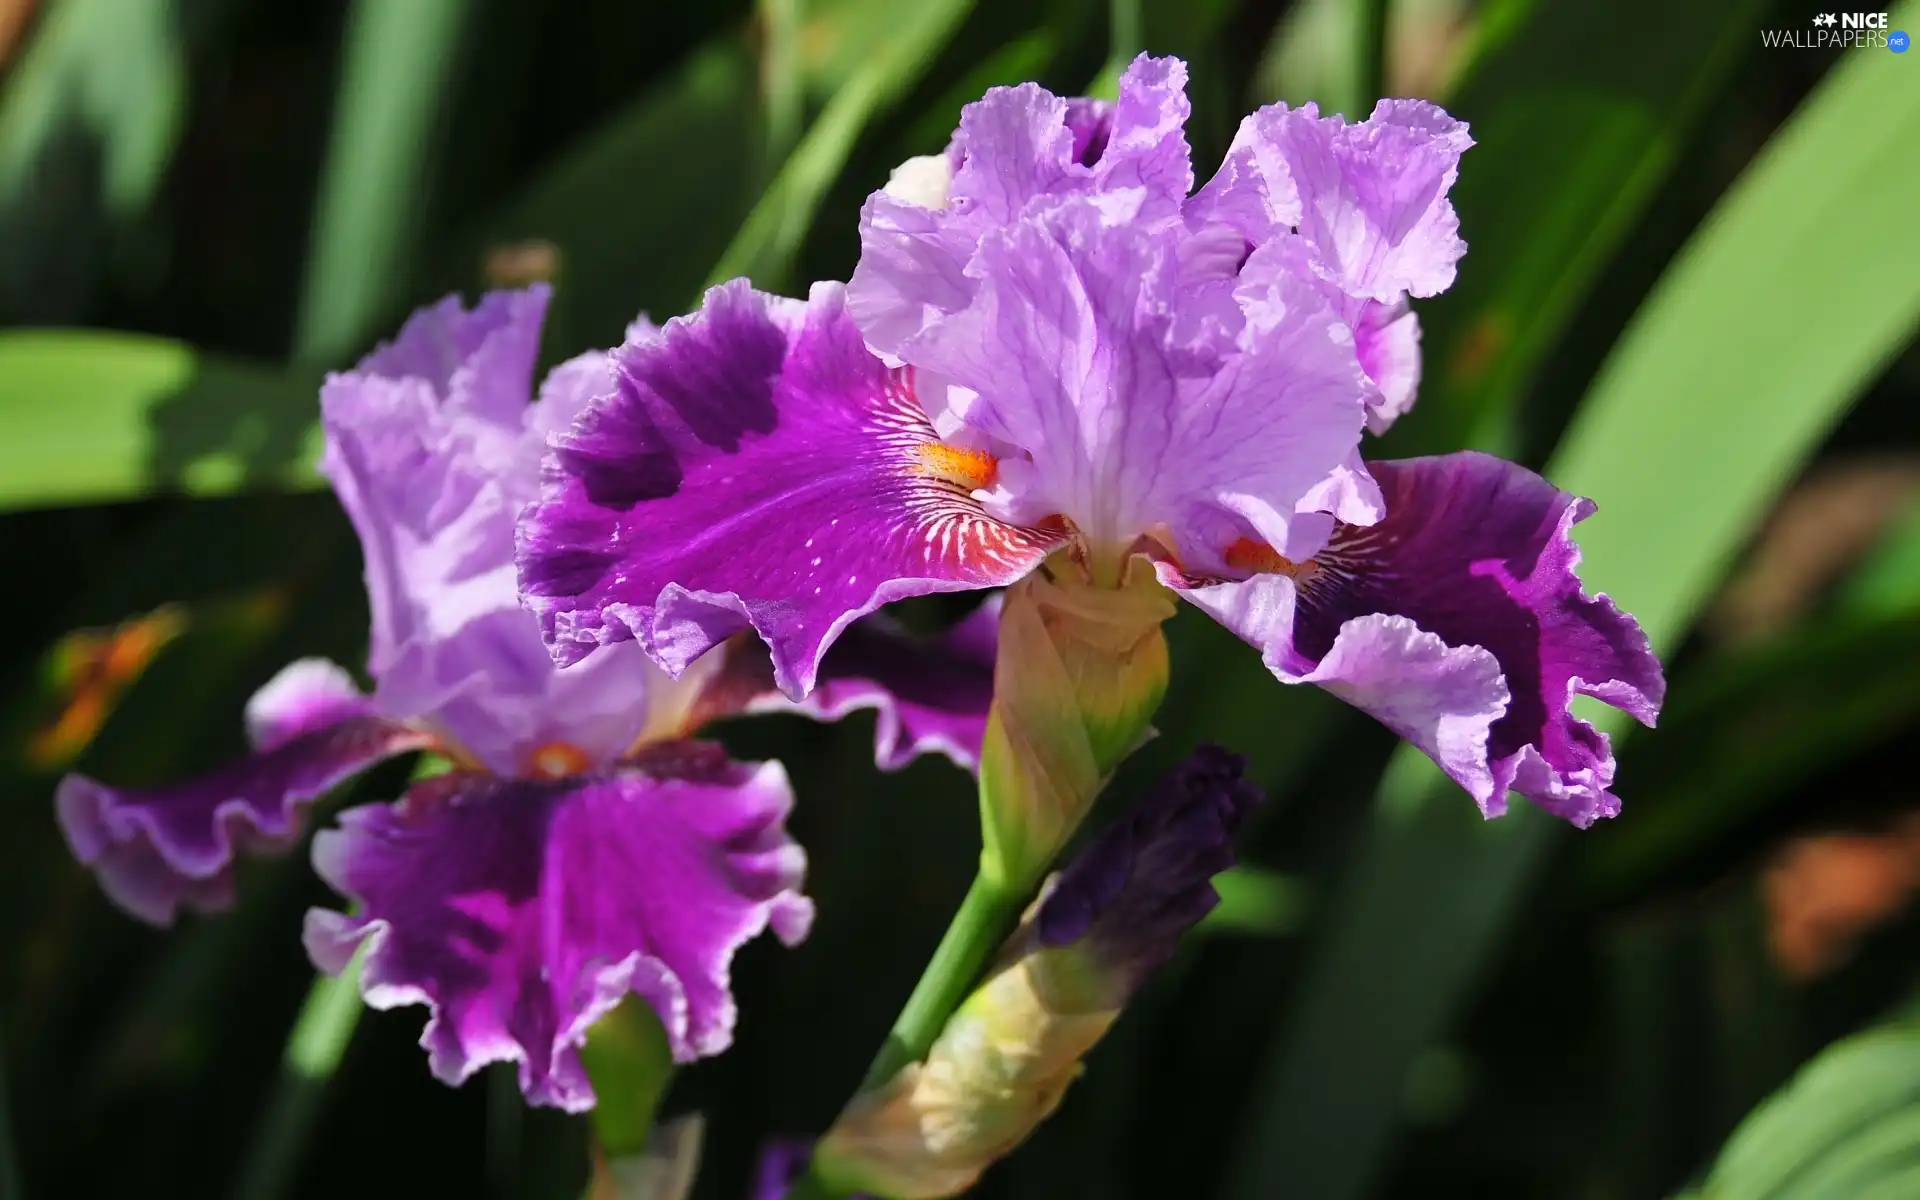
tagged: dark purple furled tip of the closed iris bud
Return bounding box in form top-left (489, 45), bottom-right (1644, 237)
top-left (1037, 743), bottom-right (1263, 983)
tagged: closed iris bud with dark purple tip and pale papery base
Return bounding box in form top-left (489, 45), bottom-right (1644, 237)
top-left (816, 747), bottom-right (1260, 1200)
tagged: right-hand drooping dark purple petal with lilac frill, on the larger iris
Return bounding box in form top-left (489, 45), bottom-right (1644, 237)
top-left (1188, 453), bottom-right (1667, 826)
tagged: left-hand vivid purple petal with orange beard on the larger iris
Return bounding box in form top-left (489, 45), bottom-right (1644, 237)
top-left (520, 280), bottom-right (1060, 699)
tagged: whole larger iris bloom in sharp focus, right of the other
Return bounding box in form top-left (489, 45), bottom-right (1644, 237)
top-left (520, 56), bottom-right (1665, 826)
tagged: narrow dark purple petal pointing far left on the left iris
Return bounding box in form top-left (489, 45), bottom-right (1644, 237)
top-left (54, 716), bottom-right (430, 925)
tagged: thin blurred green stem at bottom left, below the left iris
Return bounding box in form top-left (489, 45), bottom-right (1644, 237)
top-left (234, 958), bottom-right (365, 1200)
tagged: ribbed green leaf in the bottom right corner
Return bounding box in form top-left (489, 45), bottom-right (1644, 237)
top-left (1692, 1023), bottom-right (1920, 1200)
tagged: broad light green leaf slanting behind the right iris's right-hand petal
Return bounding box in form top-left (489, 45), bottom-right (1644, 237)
top-left (1231, 4), bottom-right (1920, 1200)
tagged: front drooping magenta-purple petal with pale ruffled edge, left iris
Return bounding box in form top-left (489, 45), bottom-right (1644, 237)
top-left (305, 755), bottom-right (812, 1112)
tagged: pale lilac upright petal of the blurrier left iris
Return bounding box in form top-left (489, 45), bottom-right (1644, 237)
top-left (321, 288), bottom-right (655, 776)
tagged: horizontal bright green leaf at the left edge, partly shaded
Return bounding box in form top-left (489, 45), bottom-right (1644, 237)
top-left (0, 330), bottom-right (319, 511)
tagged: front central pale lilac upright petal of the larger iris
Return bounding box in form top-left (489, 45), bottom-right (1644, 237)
top-left (906, 202), bottom-right (1371, 563)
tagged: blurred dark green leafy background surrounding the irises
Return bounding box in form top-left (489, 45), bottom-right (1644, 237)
top-left (0, 0), bottom-right (1920, 1200)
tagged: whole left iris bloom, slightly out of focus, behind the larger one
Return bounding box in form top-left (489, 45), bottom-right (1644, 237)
top-left (58, 288), bottom-right (995, 1110)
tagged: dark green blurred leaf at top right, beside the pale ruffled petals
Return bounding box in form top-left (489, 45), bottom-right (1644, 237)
top-left (1388, 0), bottom-right (1764, 455)
